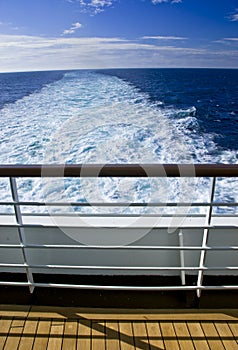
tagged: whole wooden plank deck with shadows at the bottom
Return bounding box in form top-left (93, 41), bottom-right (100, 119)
top-left (0, 305), bottom-right (238, 350)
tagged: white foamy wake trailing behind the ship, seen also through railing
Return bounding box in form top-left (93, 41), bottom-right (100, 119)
top-left (0, 71), bottom-right (238, 213)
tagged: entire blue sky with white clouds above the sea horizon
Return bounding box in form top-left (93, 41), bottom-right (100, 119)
top-left (0, 0), bottom-right (238, 72)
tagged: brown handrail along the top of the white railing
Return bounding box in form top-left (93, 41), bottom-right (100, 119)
top-left (0, 164), bottom-right (238, 177)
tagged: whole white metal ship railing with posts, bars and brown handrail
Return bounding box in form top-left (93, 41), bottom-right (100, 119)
top-left (0, 165), bottom-right (238, 297)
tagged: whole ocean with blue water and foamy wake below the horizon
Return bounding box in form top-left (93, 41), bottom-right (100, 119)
top-left (0, 69), bottom-right (238, 213)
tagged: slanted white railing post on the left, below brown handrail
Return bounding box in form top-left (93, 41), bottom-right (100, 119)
top-left (9, 177), bottom-right (35, 293)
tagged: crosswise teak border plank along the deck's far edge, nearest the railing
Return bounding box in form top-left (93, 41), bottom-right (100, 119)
top-left (18, 305), bottom-right (238, 322)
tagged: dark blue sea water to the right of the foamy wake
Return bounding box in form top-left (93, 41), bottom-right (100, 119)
top-left (99, 69), bottom-right (238, 150)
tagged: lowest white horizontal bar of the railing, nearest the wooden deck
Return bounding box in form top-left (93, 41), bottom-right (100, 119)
top-left (0, 281), bottom-right (238, 291)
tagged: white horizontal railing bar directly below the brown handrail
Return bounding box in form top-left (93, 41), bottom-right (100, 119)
top-left (0, 201), bottom-right (238, 207)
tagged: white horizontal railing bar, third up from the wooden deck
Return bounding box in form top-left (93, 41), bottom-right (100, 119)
top-left (0, 244), bottom-right (238, 251)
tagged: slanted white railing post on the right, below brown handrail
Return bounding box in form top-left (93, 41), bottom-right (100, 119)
top-left (197, 177), bottom-right (216, 298)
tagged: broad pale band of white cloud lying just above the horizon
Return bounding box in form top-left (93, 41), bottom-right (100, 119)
top-left (0, 35), bottom-right (238, 72)
